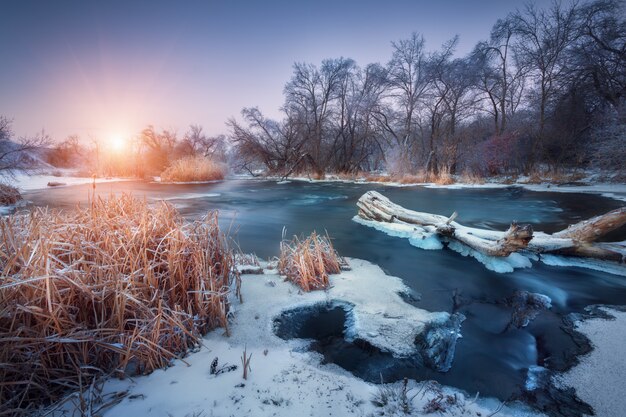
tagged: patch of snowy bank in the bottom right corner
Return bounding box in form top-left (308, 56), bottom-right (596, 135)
top-left (557, 308), bottom-right (626, 417)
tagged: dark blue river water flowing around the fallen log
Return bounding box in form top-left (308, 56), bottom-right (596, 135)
top-left (25, 180), bottom-right (626, 412)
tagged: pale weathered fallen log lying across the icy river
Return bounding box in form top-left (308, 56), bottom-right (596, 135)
top-left (357, 191), bottom-right (626, 263)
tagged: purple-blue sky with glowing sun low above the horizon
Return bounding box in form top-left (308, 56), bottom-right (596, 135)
top-left (0, 0), bottom-right (548, 140)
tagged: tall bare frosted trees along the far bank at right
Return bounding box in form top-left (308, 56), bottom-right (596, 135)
top-left (228, 0), bottom-right (626, 176)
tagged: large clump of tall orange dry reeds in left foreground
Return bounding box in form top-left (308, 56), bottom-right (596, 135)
top-left (0, 195), bottom-right (238, 415)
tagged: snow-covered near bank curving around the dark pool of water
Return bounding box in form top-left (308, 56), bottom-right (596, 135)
top-left (53, 259), bottom-right (537, 417)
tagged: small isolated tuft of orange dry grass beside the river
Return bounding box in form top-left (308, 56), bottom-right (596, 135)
top-left (278, 232), bottom-right (343, 291)
